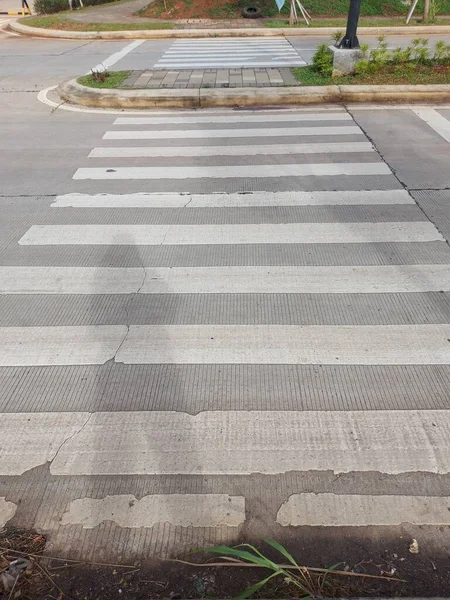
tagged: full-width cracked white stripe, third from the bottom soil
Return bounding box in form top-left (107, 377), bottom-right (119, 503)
top-left (0, 324), bottom-right (450, 367)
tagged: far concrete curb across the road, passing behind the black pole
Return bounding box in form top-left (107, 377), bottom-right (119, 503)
top-left (9, 22), bottom-right (450, 40)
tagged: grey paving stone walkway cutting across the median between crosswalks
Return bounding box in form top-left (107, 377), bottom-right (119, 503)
top-left (120, 67), bottom-right (299, 89)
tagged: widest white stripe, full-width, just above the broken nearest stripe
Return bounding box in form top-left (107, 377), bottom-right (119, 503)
top-left (0, 410), bottom-right (450, 475)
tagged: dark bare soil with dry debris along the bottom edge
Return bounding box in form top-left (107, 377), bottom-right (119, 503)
top-left (0, 527), bottom-right (450, 600)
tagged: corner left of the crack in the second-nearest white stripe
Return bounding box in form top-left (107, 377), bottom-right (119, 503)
top-left (0, 412), bottom-right (90, 475)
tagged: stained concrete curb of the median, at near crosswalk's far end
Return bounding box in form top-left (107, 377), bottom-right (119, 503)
top-left (57, 79), bottom-right (450, 108)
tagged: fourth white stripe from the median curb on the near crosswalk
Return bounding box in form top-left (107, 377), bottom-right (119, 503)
top-left (73, 161), bottom-right (392, 180)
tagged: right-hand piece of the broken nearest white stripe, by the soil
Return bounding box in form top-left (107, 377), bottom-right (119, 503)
top-left (277, 493), bottom-right (450, 527)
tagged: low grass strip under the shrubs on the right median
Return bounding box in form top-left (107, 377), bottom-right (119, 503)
top-left (292, 65), bottom-right (450, 85)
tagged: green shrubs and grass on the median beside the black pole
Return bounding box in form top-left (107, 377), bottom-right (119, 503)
top-left (293, 33), bottom-right (450, 85)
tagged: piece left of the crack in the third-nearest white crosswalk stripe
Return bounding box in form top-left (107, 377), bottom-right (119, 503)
top-left (0, 325), bottom-right (127, 367)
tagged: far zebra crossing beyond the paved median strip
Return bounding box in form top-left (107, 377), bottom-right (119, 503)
top-left (153, 38), bottom-right (306, 69)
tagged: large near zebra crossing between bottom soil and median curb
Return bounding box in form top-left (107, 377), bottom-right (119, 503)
top-left (0, 108), bottom-right (450, 560)
